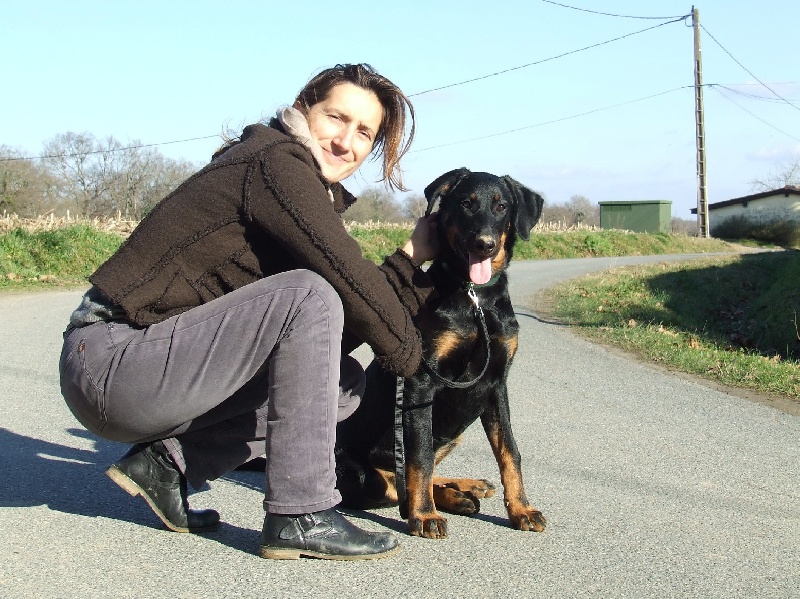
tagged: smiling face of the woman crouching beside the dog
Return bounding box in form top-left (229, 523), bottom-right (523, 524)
top-left (306, 83), bottom-right (383, 183)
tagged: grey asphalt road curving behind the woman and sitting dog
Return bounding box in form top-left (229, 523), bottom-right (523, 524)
top-left (0, 256), bottom-right (800, 599)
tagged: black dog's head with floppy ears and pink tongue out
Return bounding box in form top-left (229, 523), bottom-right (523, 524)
top-left (425, 168), bottom-right (543, 284)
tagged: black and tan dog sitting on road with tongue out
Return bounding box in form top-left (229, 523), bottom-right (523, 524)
top-left (336, 168), bottom-right (545, 538)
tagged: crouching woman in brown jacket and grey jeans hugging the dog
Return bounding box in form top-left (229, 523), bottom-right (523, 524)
top-left (60, 65), bottom-right (437, 559)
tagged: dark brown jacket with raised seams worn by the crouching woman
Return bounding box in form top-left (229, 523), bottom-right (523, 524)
top-left (89, 121), bottom-right (433, 376)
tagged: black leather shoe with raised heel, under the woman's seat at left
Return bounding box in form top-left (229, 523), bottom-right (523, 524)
top-left (106, 441), bottom-right (219, 532)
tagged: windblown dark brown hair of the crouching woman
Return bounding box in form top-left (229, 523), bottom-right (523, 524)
top-left (295, 63), bottom-right (415, 191)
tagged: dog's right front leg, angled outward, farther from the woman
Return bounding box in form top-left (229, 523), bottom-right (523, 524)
top-left (481, 386), bottom-right (547, 532)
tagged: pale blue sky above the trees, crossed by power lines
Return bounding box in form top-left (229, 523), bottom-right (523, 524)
top-left (0, 0), bottom-right (800, 218)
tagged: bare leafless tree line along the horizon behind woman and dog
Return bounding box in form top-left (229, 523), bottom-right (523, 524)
top-left (9, 132), bottom-right (784, 232)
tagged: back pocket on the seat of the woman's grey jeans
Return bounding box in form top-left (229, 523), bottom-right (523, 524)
top-left (59, 323), bottom-right (114, 435)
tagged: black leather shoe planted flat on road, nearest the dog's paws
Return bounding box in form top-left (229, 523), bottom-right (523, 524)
top-left (261, 508), bottom-right (399, 560)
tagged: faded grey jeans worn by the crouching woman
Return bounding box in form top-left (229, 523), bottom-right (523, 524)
top-left (59, 270), bottom-right (364, 514)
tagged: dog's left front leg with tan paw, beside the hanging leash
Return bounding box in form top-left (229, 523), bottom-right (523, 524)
top-left (403, 389), bottom-right (447, 539)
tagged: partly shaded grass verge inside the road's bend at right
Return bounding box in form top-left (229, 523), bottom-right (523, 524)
top-left (544, 251), bottom-right (800, 406)
